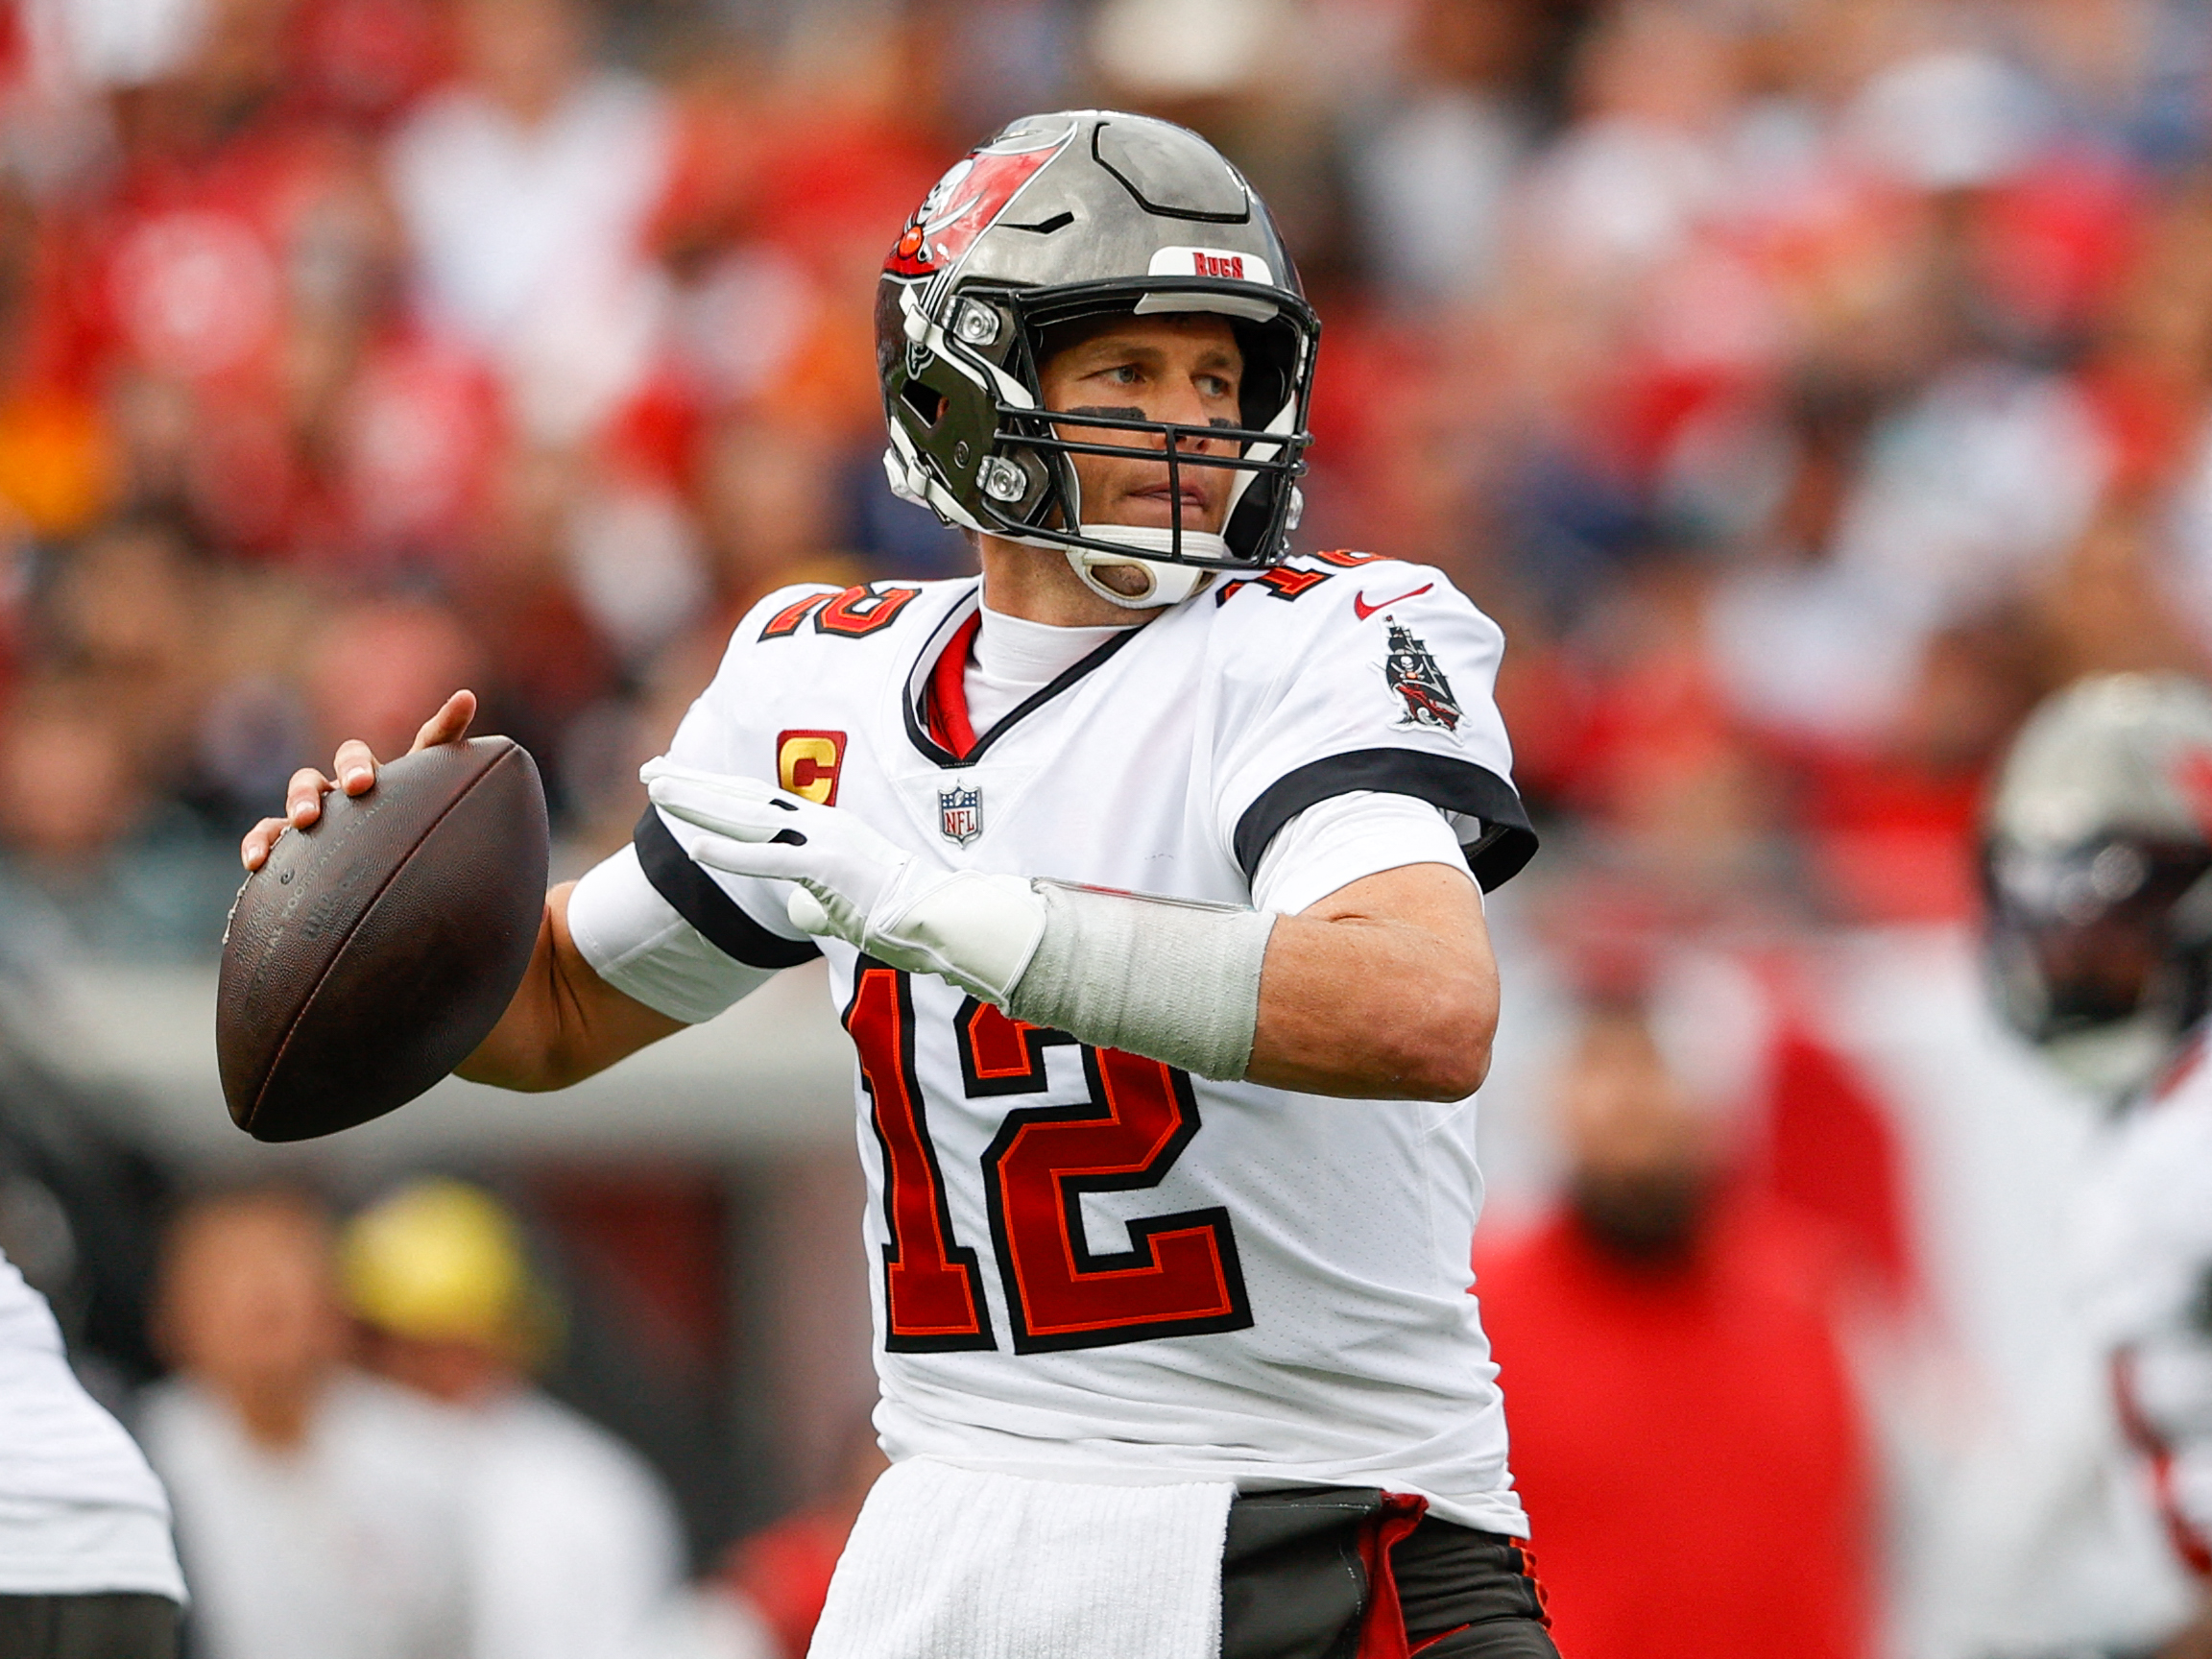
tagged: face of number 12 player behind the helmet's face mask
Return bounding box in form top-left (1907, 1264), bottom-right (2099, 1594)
top-left (1040, 312), bottom-right (1243, 536)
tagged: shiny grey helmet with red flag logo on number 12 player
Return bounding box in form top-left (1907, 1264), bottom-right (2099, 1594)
top-left (876, 110), bottom-right (1320, 606)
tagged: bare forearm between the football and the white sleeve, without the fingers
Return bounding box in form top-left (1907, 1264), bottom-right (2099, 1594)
top-left (453, 882), bottom-right (684, 1091)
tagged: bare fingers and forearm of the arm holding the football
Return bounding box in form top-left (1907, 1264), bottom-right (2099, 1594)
top-left (239, 690), bottom-right (684, 1091)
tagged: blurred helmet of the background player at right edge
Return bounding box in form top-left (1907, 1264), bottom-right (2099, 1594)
top-left (1982, 675), bottom-right (2212, 1097)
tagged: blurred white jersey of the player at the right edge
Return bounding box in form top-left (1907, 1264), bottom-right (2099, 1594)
top-left (2080, 1033), bottom-right (2212, 1579)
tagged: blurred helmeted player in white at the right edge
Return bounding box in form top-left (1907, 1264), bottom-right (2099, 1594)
top-left (1984, 675), bottom-right (2212, 1659)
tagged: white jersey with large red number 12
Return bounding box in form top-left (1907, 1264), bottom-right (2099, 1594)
top-left (570, 553), bottom-right (1535, 1533)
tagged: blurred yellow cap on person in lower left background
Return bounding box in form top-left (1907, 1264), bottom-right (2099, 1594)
top-left (341, 1177), bottom-right (558, 1362)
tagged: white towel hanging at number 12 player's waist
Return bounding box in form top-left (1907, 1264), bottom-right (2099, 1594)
top-left (807, 1457), bottom-right (1237, 1659)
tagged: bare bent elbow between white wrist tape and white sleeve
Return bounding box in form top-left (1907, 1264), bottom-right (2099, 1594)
top-left (1245, 865), bottom-right (1498, 1099)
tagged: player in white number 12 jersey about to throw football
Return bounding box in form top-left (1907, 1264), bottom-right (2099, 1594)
top-left (246, 110), bottom-right (1552, 1659)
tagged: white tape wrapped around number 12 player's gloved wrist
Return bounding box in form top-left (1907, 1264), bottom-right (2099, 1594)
top-left (1006, 880), bottom-right (1274, 1082)
